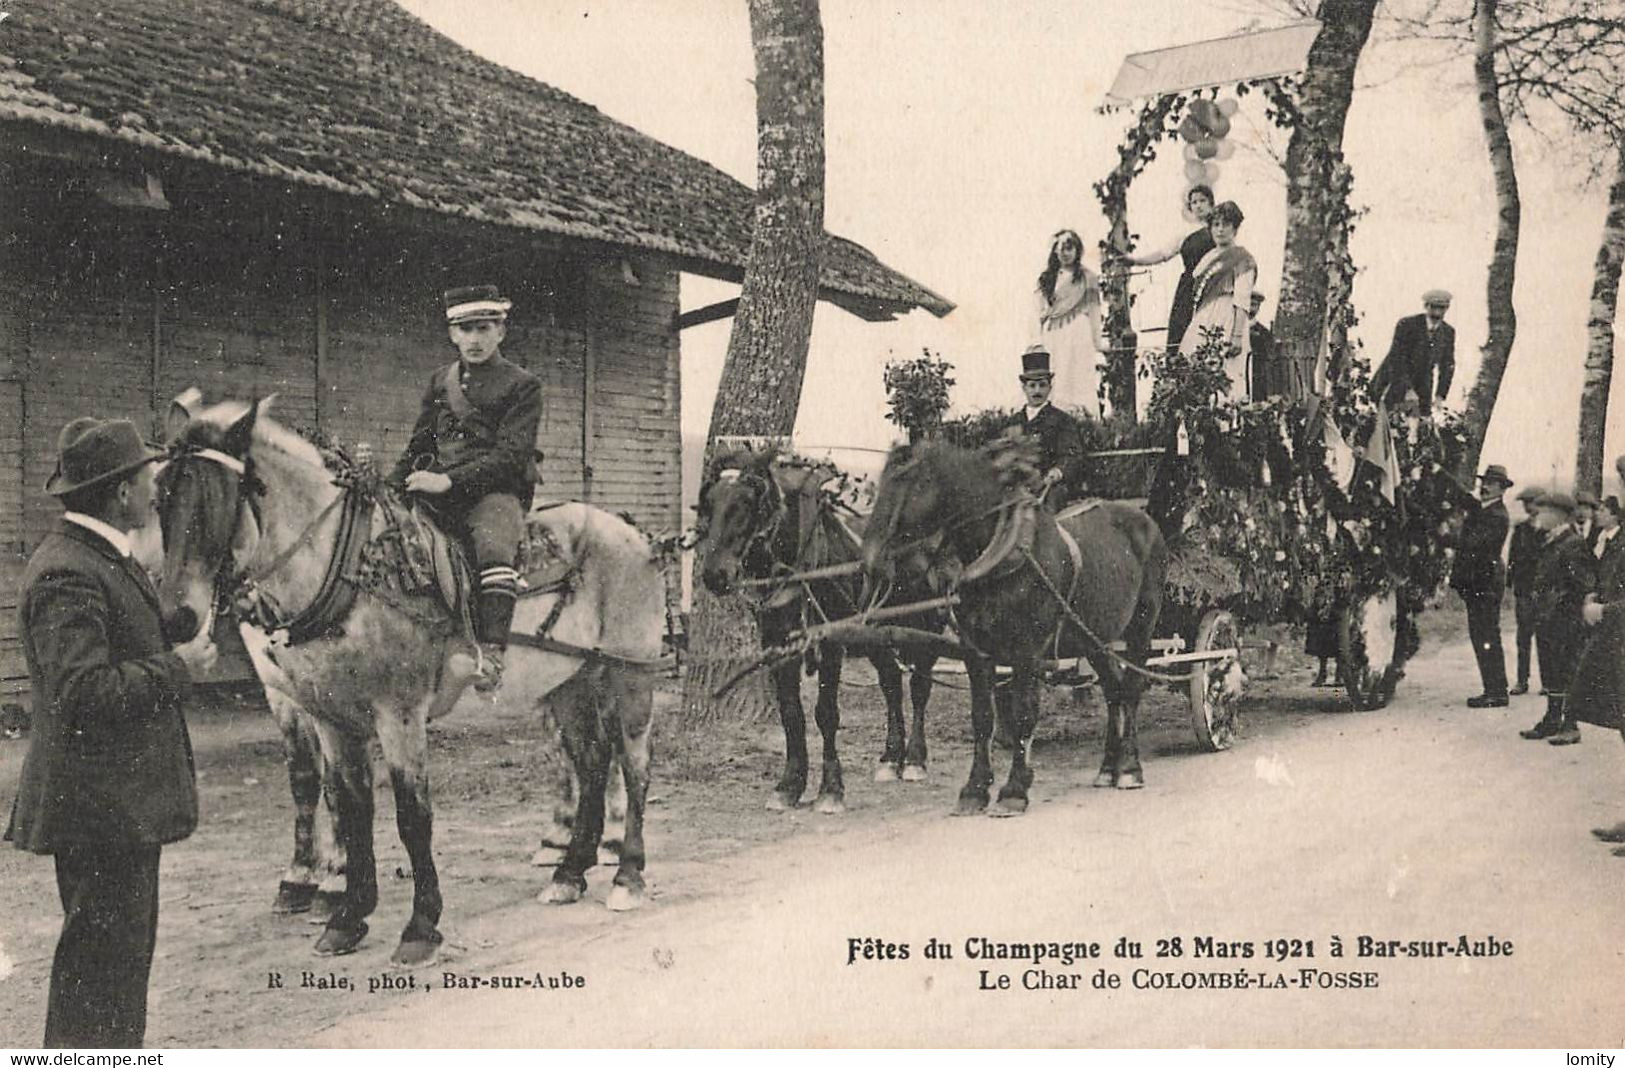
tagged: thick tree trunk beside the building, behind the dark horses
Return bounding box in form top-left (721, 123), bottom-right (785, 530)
top-left (683, 0), bottom-right (824, 723)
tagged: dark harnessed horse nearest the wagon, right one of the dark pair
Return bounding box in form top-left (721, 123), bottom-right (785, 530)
top-left (863, 441), bottom-right (1167, 816)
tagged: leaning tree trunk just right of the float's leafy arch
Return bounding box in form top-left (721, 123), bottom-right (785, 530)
top-left (1274, 0), bottom-right (1376, 395)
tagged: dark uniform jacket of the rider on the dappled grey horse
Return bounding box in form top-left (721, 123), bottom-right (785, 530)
top-left (393, 353), bottom-right (541, 507)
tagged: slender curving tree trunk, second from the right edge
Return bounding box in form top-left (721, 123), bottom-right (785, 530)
top-left (1461, 0), bottom-right (1523, 475)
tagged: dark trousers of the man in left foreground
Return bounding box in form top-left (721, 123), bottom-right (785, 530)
top-left (46, 844), bottom-right (159, 1048)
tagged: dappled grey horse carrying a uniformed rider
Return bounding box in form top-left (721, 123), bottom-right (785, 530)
top-left (158, 395), bottom-right (665, 966)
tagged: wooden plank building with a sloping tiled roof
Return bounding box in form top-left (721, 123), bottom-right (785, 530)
top-left (0, 0), bottom-right (951, 692)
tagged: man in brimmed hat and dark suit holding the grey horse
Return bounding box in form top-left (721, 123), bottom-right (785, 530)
top-left (7, 418), bottom-right (218, 1048)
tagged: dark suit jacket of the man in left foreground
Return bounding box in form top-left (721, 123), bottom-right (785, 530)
top-left (7, 520), bottom-right (198, 853)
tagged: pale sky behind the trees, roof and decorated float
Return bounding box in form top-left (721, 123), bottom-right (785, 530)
top-left (403, 0), bottom-right (1625, 493)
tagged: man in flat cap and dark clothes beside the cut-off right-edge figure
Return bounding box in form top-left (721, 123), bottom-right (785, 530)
top-left (1519, 493), bottom-right (1597, 746)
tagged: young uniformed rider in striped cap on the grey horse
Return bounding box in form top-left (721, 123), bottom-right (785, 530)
top-left (392, 286), bottom-right (541, 692)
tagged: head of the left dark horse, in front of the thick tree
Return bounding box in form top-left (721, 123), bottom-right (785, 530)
top-left (697, 450), bottom-right (785, 595)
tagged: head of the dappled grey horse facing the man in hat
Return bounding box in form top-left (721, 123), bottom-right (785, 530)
top-left (158, 390), bottom-right (271, 637)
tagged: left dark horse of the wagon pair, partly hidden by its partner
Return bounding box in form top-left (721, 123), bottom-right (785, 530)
top-left (697, 450), bottom-right (943, 814)
